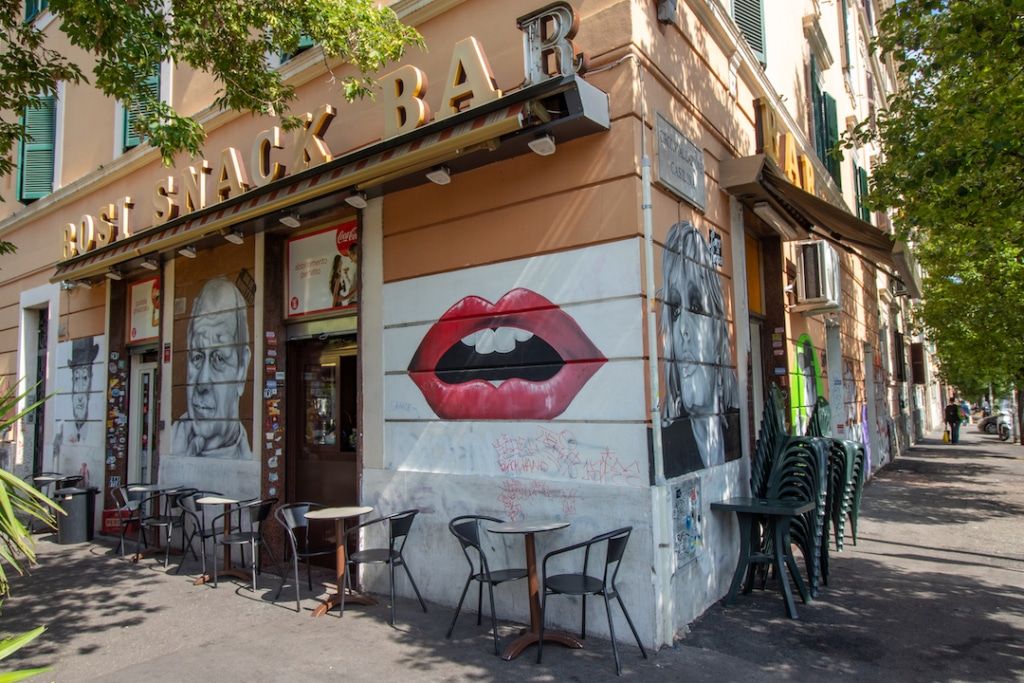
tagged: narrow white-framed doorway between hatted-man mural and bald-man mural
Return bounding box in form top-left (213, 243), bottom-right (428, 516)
top-left (125, 351), bottom-right (157, 483)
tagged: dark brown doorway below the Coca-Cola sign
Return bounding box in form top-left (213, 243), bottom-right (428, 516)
top-left (286, 336), bottom-right (360, 506)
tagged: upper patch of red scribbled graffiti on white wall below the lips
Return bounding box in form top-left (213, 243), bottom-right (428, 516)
top-left (494, 428), bottom-right (640, 483)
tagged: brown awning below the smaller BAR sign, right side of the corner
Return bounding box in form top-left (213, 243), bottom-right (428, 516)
top-left (721, 154), bottom-right (921, 299)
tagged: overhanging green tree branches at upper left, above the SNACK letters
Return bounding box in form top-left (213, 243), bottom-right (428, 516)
top-left (0, 0), bottom-right (422, 175)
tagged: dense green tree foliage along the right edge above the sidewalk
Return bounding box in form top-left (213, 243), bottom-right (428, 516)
top-left (846, 0), bottom-right (1024, 395)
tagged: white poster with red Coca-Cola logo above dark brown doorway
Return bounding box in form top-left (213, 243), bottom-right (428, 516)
top-left (286, 220), bottom-right (359, 317)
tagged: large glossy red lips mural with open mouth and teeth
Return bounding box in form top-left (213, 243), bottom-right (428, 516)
top-left (409, 289), bottom-right (607, 420)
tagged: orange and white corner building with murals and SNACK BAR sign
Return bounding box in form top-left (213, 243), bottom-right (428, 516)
top-left (0, 0), bottom-right (941, 644)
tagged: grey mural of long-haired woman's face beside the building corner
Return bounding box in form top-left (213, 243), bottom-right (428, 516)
top-left (660, 222), bottom-right (739, 475)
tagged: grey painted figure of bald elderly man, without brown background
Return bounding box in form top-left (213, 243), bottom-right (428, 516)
top-left (171, 278), bottom-right (252, 459)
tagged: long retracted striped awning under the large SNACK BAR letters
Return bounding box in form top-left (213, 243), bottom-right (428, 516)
top-left (50, 76), bottom-right (609, 282)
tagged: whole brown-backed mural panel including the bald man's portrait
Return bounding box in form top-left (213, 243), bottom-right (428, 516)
top-left (171, 253), bottom-right (253, 460)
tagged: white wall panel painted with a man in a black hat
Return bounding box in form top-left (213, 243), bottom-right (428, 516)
top-left (51, 336), bottom-right (104, 484)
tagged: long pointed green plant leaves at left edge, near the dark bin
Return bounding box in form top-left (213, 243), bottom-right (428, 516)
top-left (0, 383), bottom-right (62, 596)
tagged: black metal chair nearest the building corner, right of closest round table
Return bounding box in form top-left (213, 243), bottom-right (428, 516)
top-left (537, 526), bottom-right (647, 676)
